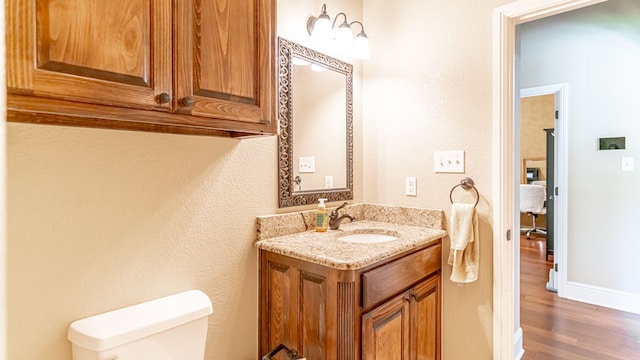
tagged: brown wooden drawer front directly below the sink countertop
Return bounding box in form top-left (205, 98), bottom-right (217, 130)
top-left (362, 244), bottom-right (441, 309)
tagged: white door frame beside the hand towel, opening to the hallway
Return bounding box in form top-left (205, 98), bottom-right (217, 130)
top-left (492, 0), bottom-right (606, 360)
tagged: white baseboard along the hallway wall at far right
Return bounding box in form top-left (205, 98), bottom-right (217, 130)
top-left (563, 281), bottom-right (640, 314)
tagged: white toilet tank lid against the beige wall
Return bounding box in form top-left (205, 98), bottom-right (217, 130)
top-left (67, 290), bottom-right (212, 351)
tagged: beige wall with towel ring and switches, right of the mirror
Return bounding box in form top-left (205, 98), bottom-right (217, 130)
top-left (363, 0), bottom-right (510, 360)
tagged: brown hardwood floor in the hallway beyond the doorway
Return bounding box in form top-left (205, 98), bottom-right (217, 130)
top-left (520, 236), bottom-right (640, 360)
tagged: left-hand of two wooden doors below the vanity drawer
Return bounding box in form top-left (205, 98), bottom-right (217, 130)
top-left (362, 294), bottom-right (410, 360)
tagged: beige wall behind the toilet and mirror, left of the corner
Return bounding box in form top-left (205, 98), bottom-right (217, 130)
top-left (3, 1), bottom-right (362, 360)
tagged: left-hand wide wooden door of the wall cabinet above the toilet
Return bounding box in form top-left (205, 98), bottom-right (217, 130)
top-left (7, 0), bottom-right (171, 110)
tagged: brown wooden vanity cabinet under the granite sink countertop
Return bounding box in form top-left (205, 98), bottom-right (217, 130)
top-left (260, 239), bottom-right (441, 360)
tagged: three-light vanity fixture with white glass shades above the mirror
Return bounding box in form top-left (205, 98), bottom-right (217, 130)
top-left (307, 4), bottom-right (371, 60)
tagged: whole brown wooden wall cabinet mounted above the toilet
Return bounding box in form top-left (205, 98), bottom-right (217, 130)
top-left (6, 0), bottom-right (277, 136)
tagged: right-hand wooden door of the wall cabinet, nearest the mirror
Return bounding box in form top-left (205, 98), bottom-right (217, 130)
top-left (174, 0), bottom-right (276, 132)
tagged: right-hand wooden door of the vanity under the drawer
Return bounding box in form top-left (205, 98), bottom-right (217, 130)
top-left (410, 275), bottom-right (440, 360)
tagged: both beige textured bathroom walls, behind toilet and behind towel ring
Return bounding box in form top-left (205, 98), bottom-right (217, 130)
top-left (7, 0), bottom-right (524, 360)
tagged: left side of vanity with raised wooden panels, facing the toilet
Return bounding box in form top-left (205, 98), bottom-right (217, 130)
top-left (260, 251), bottom-right (338, 360)
